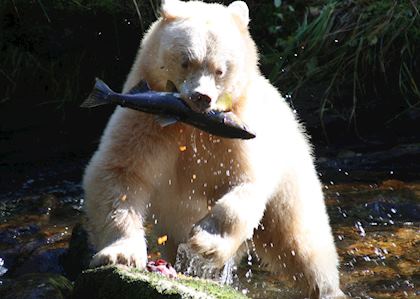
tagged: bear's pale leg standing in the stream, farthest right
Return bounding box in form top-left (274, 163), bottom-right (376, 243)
top-left (253, 179), bottom-right (345, 299)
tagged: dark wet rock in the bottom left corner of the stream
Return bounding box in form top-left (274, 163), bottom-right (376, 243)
top-left (0, 273), bottom-right (73, 299)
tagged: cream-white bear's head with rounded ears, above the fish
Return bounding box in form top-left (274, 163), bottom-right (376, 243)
top-left (141, 0), bottom-right (259, 111)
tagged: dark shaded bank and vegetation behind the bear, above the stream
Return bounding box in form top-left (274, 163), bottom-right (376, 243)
top-left (0, 0), bottom-right (420, 184)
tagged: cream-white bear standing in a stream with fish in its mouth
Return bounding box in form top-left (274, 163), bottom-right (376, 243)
top-left (83, 0), bottom-right (343, 298)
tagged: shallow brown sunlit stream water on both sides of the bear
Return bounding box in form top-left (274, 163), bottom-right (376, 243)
top-left (0, 170), bottom-right (420, 298)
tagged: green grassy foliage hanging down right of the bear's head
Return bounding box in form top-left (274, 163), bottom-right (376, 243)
top-left (264, 0), bottom-right (420, 131)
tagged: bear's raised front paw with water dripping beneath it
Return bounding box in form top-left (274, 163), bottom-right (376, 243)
top-left (188, 215), bottom-right (237, 268)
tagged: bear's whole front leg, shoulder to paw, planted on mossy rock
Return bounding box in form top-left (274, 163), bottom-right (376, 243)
top-left (83, 108), bottom-right (177, 268)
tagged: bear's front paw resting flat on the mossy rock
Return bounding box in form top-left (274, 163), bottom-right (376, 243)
top-left (90, 239), bottom-right (147, 269)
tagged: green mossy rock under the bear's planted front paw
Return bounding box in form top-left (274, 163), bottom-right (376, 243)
top-left (73, 266), bottom-right (247, 299)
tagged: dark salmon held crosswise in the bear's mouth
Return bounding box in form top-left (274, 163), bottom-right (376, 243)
top-left (80, 78), bottom-right (256, 139)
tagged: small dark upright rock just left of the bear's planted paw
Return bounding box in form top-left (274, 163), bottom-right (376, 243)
top-left (60, 223), bottom-right (94, 280)
